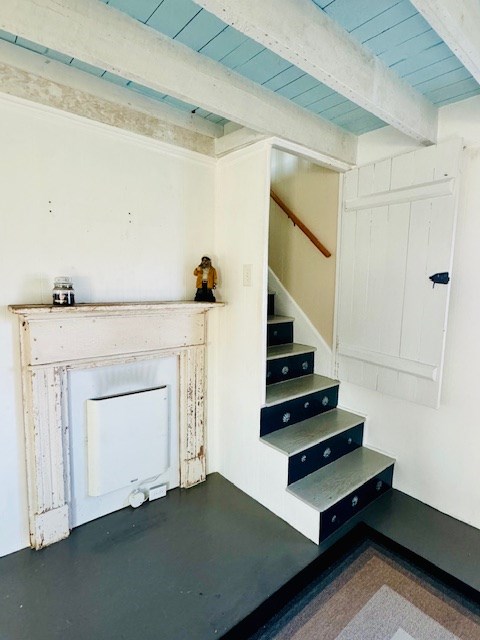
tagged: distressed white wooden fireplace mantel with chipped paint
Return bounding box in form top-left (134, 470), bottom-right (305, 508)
top-left (9, 302), bottom-right (223, 549)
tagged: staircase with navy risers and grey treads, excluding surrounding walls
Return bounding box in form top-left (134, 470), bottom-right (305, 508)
top-left (260, 293), bottom-right (395, 542)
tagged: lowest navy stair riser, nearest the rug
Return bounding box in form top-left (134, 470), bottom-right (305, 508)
top-left (320, 464), bottom-right (393, 542)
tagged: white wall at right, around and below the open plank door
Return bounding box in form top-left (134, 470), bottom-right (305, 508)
top-left (340, 98), bottom-right (480, 533)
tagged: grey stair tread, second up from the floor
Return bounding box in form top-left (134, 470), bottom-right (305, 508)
top-left (262, 408), bottom-right (365, 456)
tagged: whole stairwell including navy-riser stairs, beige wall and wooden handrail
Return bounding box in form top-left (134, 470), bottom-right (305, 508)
top-left (259, 144), bottom-right (394, 542)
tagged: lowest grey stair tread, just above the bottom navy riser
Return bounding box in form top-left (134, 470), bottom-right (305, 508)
top-left (287, 447), bottom-right (395, 512)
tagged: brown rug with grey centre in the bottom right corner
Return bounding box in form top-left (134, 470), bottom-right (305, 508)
top-left (250, 542), bottom-right (480, 640)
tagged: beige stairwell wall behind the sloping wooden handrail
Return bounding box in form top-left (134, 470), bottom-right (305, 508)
top-left (268, 149), bottom-right (340, 364)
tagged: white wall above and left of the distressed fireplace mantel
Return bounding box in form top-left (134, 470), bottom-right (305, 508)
top-left (0, 97), bottom-right (218, 555)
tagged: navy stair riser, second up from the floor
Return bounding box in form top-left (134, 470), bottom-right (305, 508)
top-left (288, 424), bottom-right (363, 484)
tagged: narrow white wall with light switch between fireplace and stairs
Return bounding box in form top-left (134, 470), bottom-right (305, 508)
top-left (215, 142), bottom-right (319, 539)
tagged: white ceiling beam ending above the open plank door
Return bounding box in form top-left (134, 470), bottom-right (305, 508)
top-left (194, 0), bottom-right (438, 144)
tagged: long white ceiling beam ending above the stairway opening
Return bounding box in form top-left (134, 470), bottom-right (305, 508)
top-left (0, 0), bottom-right (357, 164)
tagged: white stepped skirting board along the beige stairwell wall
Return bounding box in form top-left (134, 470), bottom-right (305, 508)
top-left (268, 267), bottom-right (334, 377)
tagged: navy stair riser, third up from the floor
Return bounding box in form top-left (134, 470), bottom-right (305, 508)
top-left (260, 385), bottom-right (338, 436)
